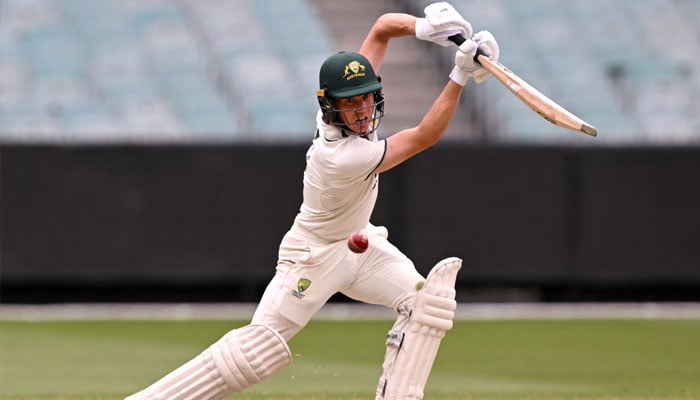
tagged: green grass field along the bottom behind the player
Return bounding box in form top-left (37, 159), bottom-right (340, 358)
top-left (0, 320), bottom-right (700, 400)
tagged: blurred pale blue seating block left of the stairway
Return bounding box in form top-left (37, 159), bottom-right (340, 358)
top-left (0, 0), bottom-right (331, 142)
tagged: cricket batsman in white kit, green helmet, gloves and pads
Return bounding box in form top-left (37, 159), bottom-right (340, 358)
top-left (127, 2), bottom-right (499, 400)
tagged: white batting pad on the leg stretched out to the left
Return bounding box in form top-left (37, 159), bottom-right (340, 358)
top-left (125, 325), bottom-right (292, 400)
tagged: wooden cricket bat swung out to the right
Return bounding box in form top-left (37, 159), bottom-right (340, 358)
top-left (449, 35), bottom-right (598, 137)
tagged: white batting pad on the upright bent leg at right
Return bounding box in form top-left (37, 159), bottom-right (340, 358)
top-left (377, 257), bottom-right (462, 400)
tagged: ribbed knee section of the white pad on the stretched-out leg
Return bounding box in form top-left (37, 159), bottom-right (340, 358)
top-left (210, 325), bottom-right (292, 392)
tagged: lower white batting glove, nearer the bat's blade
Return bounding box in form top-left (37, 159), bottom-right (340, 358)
top-left (450, 31), bottom-right (500, 86)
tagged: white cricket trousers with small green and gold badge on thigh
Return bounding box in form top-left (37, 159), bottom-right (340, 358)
top-left (251, 225), bottom-right (424, 341)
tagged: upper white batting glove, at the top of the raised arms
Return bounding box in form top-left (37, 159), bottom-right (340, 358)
top-left (416, 2), bottom-right (472, 47)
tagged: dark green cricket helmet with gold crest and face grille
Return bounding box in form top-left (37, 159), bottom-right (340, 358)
top-left (316, 51), bottom-right (384, 133)
